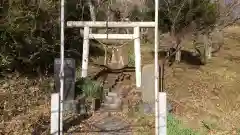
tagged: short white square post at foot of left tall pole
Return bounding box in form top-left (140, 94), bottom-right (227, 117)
top-left (50, 93), bottom-right (60, 135)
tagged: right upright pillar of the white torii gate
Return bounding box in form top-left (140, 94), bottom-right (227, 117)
top-left (134, 27), bottom-right (142, 88)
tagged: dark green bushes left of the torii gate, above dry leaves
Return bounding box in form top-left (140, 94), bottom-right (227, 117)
top-left (0, 0), bottom-right (89, 73)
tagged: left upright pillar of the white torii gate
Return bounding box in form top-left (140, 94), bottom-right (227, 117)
top-left (81, 26), bottom-right (89, 77)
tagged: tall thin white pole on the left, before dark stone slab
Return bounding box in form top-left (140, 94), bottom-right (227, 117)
top-left (59, 0), bottom-right (65, 135)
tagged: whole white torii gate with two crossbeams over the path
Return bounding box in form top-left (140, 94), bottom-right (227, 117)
top-left (67, 21), bottom-right (155, 88)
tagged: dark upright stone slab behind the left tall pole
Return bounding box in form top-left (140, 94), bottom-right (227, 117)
top-left (54, 58), bottom-right (76, 113)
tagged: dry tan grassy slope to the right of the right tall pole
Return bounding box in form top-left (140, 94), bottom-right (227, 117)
top-left (139, 26), bottom-right (240, 135)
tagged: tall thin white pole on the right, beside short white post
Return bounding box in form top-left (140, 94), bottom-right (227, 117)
top-left (154, 0), bottom-right (159, 135)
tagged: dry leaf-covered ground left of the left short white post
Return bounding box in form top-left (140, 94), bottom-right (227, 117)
top-left (0, 75), bottom-right (52, 135)
